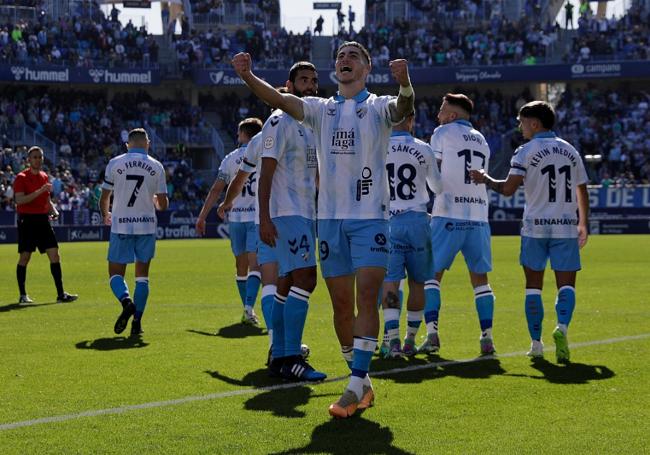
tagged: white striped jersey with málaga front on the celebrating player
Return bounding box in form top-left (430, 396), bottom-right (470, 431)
top-left (302, 89), bottom-right (394, 219)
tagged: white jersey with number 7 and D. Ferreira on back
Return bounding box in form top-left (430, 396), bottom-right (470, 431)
top-left (102, 149), bottom-right (167, 235)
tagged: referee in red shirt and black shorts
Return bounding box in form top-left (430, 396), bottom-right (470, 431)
top-left (14, 146), bottom-right (78, 305)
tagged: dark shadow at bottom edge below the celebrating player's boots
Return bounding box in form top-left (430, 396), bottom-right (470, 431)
top-left (273, 416), bottom-right (411, 455)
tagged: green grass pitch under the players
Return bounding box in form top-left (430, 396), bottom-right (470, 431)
top-left (0, 236), bottom-right (650, 455)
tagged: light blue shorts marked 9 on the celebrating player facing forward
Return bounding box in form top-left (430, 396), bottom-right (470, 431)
top-left (318, 219), bottom-right (390, 278)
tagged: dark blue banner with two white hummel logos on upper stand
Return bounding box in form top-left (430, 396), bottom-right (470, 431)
top-left (0, 64), bottom-right (161, 85)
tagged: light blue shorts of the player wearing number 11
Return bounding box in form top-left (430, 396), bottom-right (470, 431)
top-left (519, 237), bottom-right (581, 272)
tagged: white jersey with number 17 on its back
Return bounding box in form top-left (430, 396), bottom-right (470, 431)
top-left (431, 120), bottom-right (490, 222)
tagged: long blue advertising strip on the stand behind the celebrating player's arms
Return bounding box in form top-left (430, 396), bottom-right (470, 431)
top-left (194, 61), bottom-right (650, 87)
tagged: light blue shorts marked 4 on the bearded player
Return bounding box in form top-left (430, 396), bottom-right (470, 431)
top-left (273, 216), bottom-right (316, 276)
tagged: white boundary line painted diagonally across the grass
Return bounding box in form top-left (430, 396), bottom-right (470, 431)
top-left (0, 333), bottom-right (650, 431)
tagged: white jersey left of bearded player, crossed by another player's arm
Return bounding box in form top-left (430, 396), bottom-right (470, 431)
top-left (217, 144), bottom-right (257, 223)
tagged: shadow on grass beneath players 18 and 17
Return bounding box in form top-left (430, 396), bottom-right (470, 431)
top-left (370, 355), bottom-right (506, 384)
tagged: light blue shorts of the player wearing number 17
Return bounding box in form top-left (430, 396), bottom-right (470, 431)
top-left (431, 216), bottom-right (492, 273)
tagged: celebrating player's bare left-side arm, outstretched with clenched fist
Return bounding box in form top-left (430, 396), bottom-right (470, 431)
top-left (232, 52), bottom-right (305, 122)
